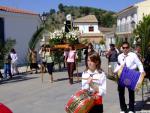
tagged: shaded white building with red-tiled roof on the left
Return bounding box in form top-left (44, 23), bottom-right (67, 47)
top-left (0, 6), bottom-right (41, 64)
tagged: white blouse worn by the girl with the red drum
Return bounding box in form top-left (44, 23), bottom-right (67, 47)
top-left (82, 70), bottom-right (106, 96)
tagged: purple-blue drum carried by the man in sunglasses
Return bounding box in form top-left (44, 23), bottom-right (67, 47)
top-left (118, 65), bottom-right (145, 91)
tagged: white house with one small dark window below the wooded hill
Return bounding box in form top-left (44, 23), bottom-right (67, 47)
top-left (73, 15), bottom-right (103, 43)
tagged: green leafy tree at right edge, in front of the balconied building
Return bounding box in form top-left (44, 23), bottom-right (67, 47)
top-left (133, 15), bottom-right (150, 57)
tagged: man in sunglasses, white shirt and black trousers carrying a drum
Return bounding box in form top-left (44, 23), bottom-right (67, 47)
top-left (114, 42), bottom-right (145, 113)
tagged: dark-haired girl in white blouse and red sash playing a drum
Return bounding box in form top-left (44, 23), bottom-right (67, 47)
top-left (82, 52), bottom-right (106, 113)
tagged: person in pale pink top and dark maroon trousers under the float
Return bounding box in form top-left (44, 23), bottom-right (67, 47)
top-left (66, 45), bottom-right (76, 85)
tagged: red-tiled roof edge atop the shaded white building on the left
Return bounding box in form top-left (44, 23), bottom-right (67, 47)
top-left (0, 6), bottom-right (38, 15)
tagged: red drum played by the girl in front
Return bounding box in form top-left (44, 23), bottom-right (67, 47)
top-left (65, 90), bottom-right (94, 113)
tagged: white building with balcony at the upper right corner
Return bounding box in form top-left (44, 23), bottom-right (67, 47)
top-left (116, 0), bottom-right (150, 40)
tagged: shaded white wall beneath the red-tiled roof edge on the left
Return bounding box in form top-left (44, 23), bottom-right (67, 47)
top-left (0, 13), bottom-right (41, 64)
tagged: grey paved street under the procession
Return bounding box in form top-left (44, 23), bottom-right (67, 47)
top-left (0, 58), bottom-right (150, 113)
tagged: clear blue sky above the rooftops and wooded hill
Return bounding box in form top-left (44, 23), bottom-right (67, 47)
top-left (0, 0), bottom-right (143, 14)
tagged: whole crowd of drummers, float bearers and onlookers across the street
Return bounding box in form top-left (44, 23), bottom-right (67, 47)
top-left (0, 42), bottom-right (150, 113)
